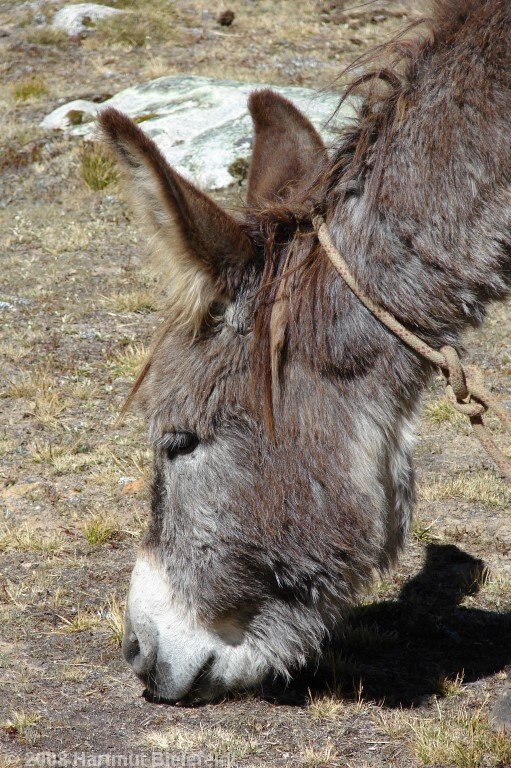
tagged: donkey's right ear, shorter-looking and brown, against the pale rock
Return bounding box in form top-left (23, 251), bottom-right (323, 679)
top-left (247, 89), bottom-right (327, 204)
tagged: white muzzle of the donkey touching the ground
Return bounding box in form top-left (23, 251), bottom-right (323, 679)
top-left (123, 554), bottom-right (324, 703)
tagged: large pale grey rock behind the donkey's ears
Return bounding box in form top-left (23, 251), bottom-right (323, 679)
top-left (41, 77), bottom-right (353, 190)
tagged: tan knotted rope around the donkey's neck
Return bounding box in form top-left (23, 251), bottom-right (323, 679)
top-left (312, 216), bottom-right (511, 485)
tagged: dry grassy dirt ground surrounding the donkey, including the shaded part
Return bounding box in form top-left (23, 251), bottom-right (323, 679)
top-left (0, 0), bottom-right (511, 768)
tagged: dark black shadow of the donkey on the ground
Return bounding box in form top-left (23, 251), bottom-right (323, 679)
top-left (265, 544), bottom-right (511, 707)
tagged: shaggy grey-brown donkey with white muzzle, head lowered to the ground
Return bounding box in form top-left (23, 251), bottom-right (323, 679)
top-left (99, 0), bottom-right (511, 702)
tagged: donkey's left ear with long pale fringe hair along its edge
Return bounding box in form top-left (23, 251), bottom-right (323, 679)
top-left (98, 108), bottom-right (254, 331)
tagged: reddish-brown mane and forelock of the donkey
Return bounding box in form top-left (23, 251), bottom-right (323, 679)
top-left (246, 0), bottom-right (504, 436)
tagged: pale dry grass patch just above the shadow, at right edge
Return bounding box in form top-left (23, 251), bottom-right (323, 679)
top-left (420, 471), bottom-right (511, 508)
